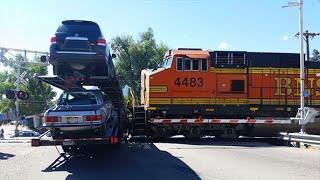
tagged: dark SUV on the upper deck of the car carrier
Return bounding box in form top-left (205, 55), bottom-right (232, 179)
top-left (49, 20), bottom-right (114, 78)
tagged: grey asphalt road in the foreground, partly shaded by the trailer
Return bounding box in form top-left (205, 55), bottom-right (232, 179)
top-left (0, 139), bottom-right (320, 180)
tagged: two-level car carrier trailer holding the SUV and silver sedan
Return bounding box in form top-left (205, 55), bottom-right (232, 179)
top-left (31, 76), bottom-right (128, 152)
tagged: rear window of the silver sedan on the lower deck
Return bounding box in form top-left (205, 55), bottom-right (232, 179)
top-left (58, 92), bottom-right (98, 105)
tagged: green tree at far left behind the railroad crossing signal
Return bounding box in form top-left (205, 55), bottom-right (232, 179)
top-left (0, 54), bottom-right (56, 115)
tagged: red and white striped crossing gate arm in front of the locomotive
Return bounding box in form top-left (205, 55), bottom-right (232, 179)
top-left (151, 118), bottom-right (291, 124)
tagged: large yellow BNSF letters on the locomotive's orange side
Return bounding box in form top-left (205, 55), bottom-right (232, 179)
top-left (274, 77), bottom-right (320, 96)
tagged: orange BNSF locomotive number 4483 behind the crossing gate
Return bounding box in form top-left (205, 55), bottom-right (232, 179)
top-left (136, 48), bottom-right (320, 137)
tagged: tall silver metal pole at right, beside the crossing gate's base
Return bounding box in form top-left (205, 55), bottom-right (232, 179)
top-left (282, 0), bottom-right (306, 133)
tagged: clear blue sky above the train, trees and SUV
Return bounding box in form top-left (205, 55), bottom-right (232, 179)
top-left (0, 0), bottom-right (320, 52)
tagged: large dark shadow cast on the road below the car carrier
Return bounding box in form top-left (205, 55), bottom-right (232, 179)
top-left (43, 143), bottom-right (200, 180)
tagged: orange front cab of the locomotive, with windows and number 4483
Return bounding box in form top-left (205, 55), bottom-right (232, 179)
top-left (141, 48), bottom-right (211, 117)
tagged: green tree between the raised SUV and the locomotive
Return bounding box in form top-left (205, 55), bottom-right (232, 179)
top-left (111, 28), bottom-right (168, 103)
